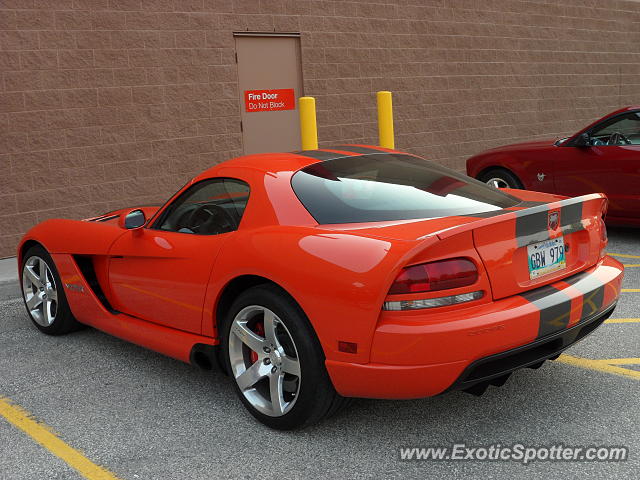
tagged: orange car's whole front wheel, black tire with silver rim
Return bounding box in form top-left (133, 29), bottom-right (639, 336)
top-left (20, 245), bottom-right (82, 335)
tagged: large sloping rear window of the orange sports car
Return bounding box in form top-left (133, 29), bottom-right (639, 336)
top-left (291, 153), bottom-right (520, 224)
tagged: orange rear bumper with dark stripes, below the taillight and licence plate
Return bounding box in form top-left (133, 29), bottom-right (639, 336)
top-left (326, 257), bottom-right (623, 399)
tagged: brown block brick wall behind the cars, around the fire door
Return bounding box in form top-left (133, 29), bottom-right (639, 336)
top-left (0, 0), bottom-right (640, 257)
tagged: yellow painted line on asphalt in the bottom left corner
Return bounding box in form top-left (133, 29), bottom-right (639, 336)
top-left (0, 396), bottom-right (118, 480)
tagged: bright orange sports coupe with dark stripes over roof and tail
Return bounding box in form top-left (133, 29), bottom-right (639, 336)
top-left (18, 145), bottom-right (623, 429)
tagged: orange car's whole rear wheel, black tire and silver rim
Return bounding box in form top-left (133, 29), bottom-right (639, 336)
top-left (223, 285), bottom-right (345, 430)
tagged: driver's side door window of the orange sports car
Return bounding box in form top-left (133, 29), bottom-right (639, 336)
top-left (153, 178), bottom-right (249, 235)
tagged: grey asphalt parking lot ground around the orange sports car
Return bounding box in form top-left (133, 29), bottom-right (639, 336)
top-left (0, 229), bottom-right (640, 479)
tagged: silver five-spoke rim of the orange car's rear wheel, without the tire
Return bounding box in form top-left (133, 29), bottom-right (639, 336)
top-left (229, 305), bottom-right (302, 417)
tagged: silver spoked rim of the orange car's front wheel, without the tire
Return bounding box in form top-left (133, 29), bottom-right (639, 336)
top-left (22, 256), bottom-right (58, 327)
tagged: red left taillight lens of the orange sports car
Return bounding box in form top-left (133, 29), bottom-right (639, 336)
top-left (389, 258), bottom-right (478, 295)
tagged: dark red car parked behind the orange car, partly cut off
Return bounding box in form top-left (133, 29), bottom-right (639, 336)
top-left (467, 107), bottom-right (640, 226)
